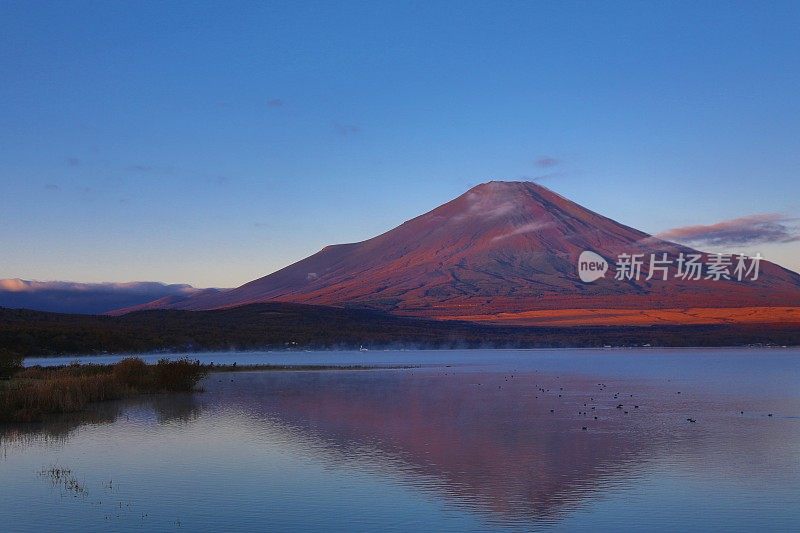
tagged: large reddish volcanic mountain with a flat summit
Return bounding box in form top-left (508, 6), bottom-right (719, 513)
top-left (119, 181), bottom-right (800, 323)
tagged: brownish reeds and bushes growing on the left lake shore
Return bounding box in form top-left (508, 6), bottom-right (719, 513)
top-left (0, 358), bottom-right (208, 422)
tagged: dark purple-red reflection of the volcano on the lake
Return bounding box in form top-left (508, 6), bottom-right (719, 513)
top-left (205, 371), bottom-right (702, 521)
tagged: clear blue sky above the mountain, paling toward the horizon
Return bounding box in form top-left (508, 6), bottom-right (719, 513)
top-left (0, 1), bottom-right (800, 286)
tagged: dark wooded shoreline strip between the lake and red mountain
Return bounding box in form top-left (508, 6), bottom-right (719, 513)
top-left (0, 302), bottom-right (800, 356)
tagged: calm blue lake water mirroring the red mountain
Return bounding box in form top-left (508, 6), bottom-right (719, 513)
top-left (0, 349), bottom-right (800, 531)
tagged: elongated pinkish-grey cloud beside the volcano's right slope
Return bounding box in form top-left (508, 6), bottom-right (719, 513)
top-left (656, 213), bottom-right (800, 246)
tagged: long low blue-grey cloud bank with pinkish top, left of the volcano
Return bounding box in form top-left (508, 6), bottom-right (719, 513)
top-left (0, 279), bottom-right (222, 314)
